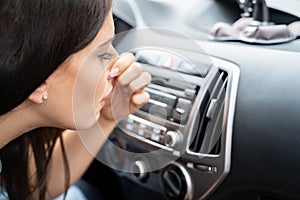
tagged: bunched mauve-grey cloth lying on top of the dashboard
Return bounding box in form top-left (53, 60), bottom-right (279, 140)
top-left (210, 17), bottom-right (300, 44)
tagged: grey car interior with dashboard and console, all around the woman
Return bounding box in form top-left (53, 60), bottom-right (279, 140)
top-left (79, 0), bottom-right (300, 200)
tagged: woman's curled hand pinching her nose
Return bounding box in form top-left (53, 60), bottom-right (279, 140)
top-left (100, 53), bottom-right (151, 121)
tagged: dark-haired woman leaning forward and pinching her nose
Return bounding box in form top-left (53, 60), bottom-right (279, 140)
top-left (0, 0), bottom-right (151, 200)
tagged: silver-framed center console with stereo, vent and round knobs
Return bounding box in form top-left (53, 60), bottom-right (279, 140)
top-left (98, 32), bottom-right (239, 199)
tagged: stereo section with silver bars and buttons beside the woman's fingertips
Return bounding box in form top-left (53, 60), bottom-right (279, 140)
top-left (141, 76), bottom-right (199, 124)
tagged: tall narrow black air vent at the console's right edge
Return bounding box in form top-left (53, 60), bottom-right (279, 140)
top-left (190, 70), bottom-right (228, 155)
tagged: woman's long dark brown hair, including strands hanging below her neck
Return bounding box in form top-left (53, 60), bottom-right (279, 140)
top-left (0, 0), bottom-right (111, 200)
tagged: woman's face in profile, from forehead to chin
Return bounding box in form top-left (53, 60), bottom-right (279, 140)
top-left (42, 11), bottom-right (118, 130)
